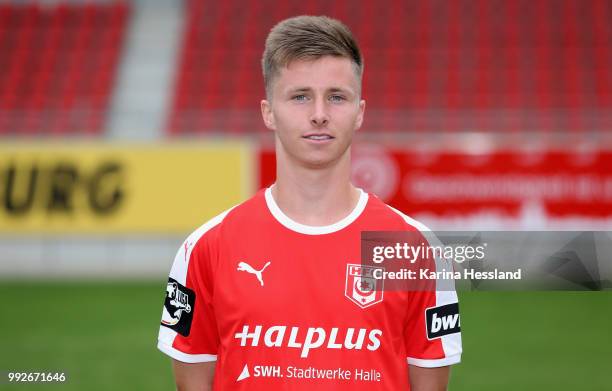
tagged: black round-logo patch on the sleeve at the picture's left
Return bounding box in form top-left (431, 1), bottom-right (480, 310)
top-left (161, 278), bottom-right (195, 337)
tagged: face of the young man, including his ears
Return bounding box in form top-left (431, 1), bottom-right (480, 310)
top-left (261, 56), bottom-right (365, 168)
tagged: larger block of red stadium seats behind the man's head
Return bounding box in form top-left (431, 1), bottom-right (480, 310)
top-left (168, 0), bottom-right (612, 135)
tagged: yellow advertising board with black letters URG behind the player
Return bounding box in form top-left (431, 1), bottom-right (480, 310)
top-left (0, 142), bottom-right (254, 234)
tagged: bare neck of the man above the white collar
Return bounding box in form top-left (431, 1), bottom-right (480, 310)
top-left (272, 155), bottom-right (361, 226)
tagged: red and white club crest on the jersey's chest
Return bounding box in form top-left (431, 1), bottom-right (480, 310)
top-left (344, 263), bottom-right (384, 308)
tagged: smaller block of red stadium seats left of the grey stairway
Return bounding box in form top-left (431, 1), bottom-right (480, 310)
top-left (0, 1), bottom-right (130, 136)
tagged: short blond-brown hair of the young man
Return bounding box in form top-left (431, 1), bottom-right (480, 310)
top-left (261, 15), bottom-right (363, 97)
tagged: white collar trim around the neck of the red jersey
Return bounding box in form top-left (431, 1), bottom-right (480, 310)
top-left (265, 185), bottom-right (368, 235)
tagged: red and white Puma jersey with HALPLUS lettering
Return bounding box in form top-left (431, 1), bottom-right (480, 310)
top-left (158, 188), bottom-right (461, 390)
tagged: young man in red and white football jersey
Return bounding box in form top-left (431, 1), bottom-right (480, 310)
top-left (158, 16), bottom-right (461, 391)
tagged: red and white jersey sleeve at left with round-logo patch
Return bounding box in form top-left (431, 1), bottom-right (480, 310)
top-left (157, 231), bottom-right (219, 363)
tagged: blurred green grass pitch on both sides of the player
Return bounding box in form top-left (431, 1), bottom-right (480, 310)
top-left (0, 281), bottom-right (612, 391)
